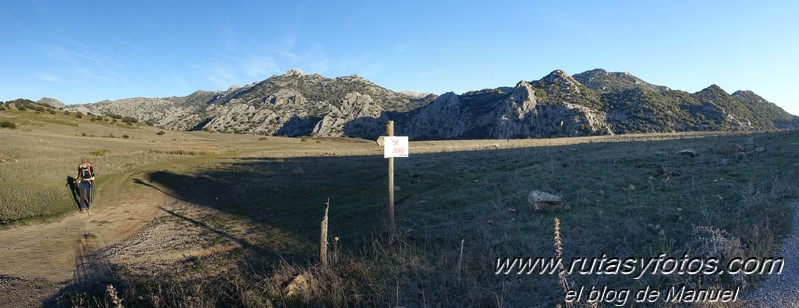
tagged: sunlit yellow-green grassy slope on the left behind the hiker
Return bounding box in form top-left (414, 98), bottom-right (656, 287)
top-left (0, 102), bottom-right (322, 225)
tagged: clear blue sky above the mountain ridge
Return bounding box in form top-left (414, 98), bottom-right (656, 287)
top-left (0, 0), bottom-right (799, 114)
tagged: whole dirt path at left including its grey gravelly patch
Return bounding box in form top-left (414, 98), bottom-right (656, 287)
top-left (0, 164), bottom-right (247, 307)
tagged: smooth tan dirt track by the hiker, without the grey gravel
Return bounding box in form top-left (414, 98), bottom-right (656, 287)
top-left (0, 172), bottom-right (166, 283)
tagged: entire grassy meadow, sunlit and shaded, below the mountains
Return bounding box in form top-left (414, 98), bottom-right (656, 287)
top-left (0, 101), bottom-right (799, 307)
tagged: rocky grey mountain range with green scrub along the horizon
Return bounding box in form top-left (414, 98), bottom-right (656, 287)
top-left (64, 69), bottom-right (799, 140)
